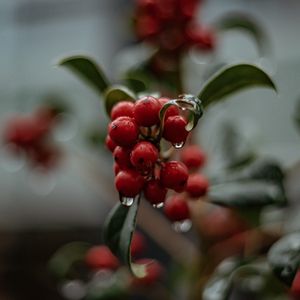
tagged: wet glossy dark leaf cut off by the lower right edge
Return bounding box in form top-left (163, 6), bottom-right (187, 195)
top-left (268, 233), bottom-right (300, 286)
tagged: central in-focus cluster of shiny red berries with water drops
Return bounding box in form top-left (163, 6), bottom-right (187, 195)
top-left (106, 96), bottom-right (208, 227)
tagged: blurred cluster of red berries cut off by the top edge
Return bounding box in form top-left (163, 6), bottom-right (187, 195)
top-left (135, 0), bottom-right (215, 52)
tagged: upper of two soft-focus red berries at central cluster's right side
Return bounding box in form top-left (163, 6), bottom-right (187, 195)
top-left (180, 145), bottom-right (206, 170)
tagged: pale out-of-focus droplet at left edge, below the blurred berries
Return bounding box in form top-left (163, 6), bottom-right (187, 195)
top-left (0, 144), bottom-right (26, 172)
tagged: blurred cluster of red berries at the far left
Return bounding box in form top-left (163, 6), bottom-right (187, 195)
top-left (4, 106), bottom-right (60, 169)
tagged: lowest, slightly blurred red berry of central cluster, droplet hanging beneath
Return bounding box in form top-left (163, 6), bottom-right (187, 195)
top-left (164, 195), bottom-right (190, 222)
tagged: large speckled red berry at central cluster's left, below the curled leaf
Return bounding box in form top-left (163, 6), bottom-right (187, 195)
top-left (108, 117), bottom-right (139, 147)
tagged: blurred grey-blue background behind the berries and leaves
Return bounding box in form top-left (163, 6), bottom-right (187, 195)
top-left (0, 0), bottom-right (300, 300)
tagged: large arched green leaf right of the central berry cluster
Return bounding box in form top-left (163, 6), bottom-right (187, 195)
top-left (198, 64), bottom-right (276, 108)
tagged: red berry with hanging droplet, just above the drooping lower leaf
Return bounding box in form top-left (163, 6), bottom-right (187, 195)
top-left (115, 170), bottom-right (144, 197)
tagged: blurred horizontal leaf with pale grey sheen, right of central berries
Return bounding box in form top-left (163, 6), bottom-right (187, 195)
top-left (209, 180), bottom-right (285, 209)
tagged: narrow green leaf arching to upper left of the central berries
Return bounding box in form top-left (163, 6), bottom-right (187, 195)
top-left (58, 55), bottom-right (110, 95)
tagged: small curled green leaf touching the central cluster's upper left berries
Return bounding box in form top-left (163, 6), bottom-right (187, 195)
top-left (104, 85), bottom-right (136, 115)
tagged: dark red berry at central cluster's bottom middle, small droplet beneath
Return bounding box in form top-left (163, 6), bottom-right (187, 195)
top-left (144, 179), bottom-right (168, 205)
